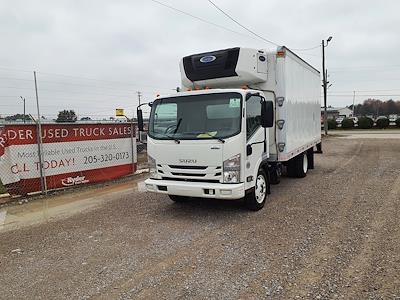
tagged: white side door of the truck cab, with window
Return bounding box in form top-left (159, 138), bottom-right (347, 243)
top-left (245, 95), bottom-right (268, 189)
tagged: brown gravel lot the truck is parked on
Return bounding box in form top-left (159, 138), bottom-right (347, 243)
top-left (0, 138), bottom-right (400, 299)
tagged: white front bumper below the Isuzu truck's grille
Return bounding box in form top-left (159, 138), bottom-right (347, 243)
top-left (144, 179), bottom-right (245, 199)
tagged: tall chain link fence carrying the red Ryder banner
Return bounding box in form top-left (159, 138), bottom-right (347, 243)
top-left (0, 68), bottom-right (156, 203)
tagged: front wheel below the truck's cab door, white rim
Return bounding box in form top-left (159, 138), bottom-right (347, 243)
top-left (244, 169), bottom-right (269, 211)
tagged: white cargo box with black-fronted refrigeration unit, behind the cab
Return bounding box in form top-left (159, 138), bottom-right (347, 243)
top-left (180, 47), bottom-right (321, 161)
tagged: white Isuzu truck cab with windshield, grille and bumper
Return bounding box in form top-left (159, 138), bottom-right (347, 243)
top-left (146, 89), bottom-right (273, 209)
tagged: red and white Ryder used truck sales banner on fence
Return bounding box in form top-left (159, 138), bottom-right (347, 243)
top-left (0, 123), bottom-right (137, 194)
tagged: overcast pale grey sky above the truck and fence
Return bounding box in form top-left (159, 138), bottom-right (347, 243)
top-left (0, 0), bottom-right (400, 119)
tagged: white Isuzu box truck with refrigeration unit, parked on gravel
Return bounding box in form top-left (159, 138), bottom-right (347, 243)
top-left (138, 47), bottom-right (321, 210)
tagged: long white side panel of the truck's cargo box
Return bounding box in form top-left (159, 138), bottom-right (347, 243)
top-left (276, 51), bottom-right (321, 161)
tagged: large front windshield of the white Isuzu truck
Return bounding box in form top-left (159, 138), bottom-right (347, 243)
top-left (149, 93), bottom-right (242, 139)
